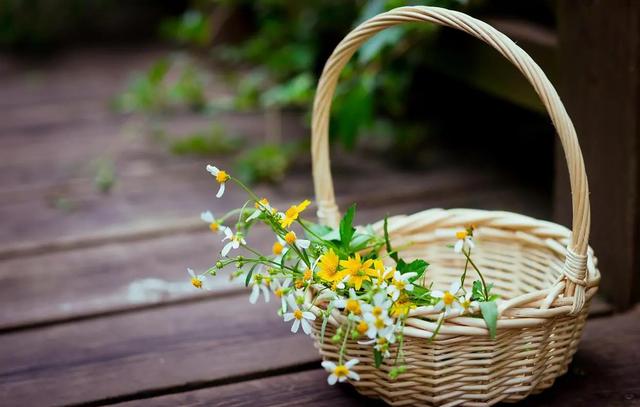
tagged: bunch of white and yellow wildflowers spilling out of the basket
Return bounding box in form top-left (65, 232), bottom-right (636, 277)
top-left (188, 165), bottom-right (497, 384)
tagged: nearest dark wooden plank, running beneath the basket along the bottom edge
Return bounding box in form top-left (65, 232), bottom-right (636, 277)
top-left (118, 309), bottom-right (640, 407)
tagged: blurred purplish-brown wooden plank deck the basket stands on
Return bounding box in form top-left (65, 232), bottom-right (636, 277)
top-left (0, 50), bottom-right (640, 406)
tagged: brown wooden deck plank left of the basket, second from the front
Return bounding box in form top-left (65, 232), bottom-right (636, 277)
top-left (0, 295), bottom-right (318, 407)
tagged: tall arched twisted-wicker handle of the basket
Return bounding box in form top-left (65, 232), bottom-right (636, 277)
top-left (311, 6), bottom-right (591, 313)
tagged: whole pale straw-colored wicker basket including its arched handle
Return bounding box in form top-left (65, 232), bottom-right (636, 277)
top-left (308, 7), bottom-right (600, 406)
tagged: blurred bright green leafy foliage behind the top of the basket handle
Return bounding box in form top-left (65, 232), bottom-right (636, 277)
top-left (115, 0), bottom-right (467, 182)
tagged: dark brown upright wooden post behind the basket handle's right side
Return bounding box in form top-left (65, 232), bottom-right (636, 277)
top-left (555, 0), bottom-right (640, 310)
